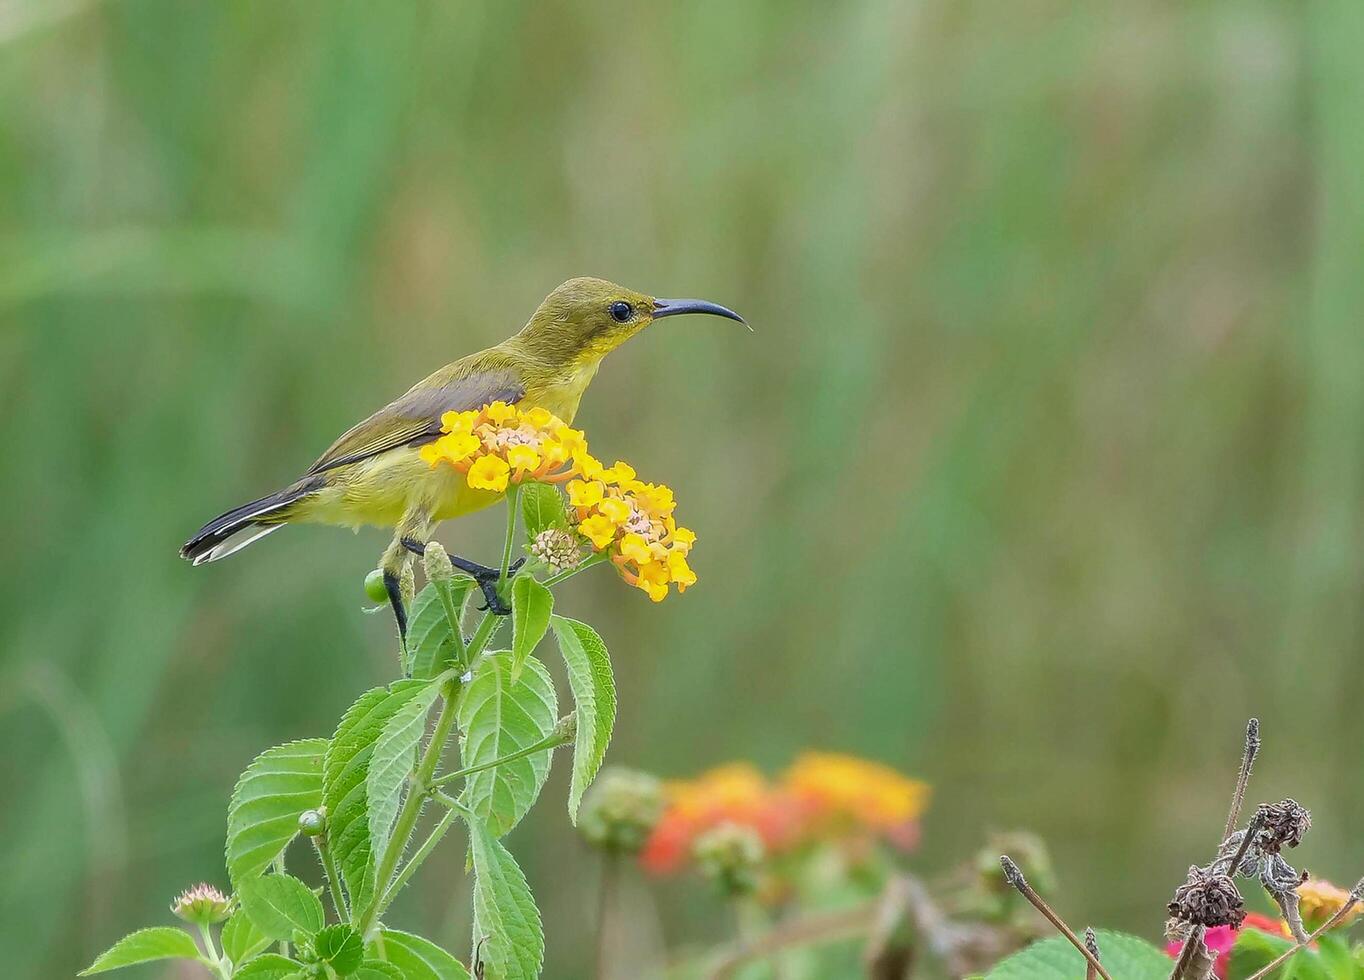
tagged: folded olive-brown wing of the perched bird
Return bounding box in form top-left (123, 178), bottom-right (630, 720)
top-left (308, 358), bottom-right (525, 474)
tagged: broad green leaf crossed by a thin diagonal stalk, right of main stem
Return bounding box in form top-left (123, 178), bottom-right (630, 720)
top-left (456, 650), bottom-right (558, 837)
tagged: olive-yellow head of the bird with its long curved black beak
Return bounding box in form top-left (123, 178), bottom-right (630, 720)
top-left (518, 276), bottom-right (746, 366)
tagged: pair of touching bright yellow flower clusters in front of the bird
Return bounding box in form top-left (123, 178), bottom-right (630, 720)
top-left (421, 401), bottom-right (696, 602)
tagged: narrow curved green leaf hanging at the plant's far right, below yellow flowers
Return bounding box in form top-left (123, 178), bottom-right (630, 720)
top-left (550, 616), bottom-right (615, 826)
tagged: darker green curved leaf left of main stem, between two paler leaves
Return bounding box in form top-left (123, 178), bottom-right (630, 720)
top-left (322, 681), bottom-right (430, 908)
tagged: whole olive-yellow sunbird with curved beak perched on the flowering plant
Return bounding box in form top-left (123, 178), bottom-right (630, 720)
top-left (180, 277), bottom-right (746, 642)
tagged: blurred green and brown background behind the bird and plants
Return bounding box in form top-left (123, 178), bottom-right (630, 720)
top-left (0, 0), bottom-right (1364, 977)
